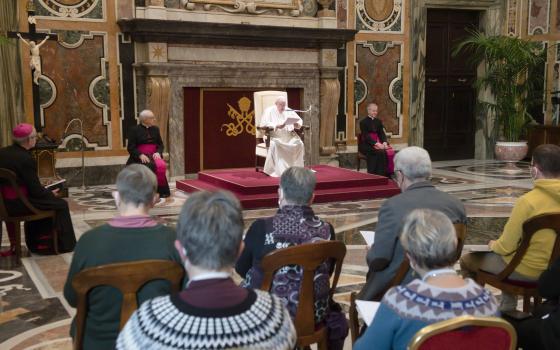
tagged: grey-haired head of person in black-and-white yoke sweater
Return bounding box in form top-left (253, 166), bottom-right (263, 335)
top-left (177, 191), bottom-right (243, 271)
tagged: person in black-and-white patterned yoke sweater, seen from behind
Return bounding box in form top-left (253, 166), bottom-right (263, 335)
top-left (117, 191), bottom-right (296, 350)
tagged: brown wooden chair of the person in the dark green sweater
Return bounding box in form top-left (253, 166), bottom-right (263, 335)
top-left (72, 260), bottom-right (185, 349)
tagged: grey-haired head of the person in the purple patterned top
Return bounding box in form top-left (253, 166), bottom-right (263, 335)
top-left (280, 166), bottom-right (317, 205)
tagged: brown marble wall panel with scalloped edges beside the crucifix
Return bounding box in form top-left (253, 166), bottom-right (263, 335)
top-left (41, 35), bottom-right (109, 147)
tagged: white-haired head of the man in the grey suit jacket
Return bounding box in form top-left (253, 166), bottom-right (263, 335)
top-left (395, 146), bottom-right (432, 182)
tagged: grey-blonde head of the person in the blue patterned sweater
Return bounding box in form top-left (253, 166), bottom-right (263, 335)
top-left (400, 209), bottom-right (457, 270)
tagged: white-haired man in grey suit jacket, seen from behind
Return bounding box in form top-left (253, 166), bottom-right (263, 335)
top-left (358, 147), bottom-right (466, 300)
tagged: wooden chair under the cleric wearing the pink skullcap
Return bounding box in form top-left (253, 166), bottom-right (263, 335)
top-left (0, 168), bottom-right (58, 265)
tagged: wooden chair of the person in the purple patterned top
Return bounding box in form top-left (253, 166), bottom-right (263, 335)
top-left (261, 241), bottom-right (346, 350)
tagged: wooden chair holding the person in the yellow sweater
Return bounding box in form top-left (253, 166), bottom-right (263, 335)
top-left (476, 213), bottom-right (560, 312)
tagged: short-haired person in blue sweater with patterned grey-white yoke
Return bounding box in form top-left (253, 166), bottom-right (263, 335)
top-left (354, 209), bottom-right (498, 350)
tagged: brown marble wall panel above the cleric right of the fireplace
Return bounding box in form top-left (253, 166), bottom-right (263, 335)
top-left (356, 41), bottom-right (402, 135)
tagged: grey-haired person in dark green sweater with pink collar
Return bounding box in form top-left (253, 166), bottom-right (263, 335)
top-left (64, 164), bottom-right (181, 349)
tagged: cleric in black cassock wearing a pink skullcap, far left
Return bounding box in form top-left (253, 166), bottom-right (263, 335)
top-left (0, 124), bottom-right (76, 254)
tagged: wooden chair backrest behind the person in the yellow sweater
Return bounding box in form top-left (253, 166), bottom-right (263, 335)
top-left (498, 213), bottom-right (560, 280)
